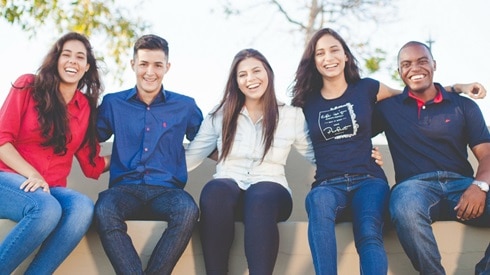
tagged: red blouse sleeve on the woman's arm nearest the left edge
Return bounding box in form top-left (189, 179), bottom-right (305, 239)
top-left (0, 74), bottom-right (34, 145)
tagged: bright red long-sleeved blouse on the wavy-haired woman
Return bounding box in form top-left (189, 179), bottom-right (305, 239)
top-left (0, 74), bottom-right (104, 187)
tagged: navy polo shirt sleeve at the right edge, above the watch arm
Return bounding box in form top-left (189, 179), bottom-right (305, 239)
top-left (464, 98), bottom-right (490, 148)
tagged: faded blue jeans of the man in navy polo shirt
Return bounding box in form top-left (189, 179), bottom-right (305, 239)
top-left (390, 171), bottom-right (490, 274)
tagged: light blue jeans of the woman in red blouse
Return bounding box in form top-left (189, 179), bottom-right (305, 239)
top-left (0, 172), bottom-right (94, 274)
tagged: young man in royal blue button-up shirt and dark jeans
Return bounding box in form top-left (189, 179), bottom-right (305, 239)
top-left (95, 35), bottom-right (203, 274)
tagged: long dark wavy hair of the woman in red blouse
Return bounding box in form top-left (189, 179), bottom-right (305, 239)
top-left (32, 32), bottom-right (103, 164)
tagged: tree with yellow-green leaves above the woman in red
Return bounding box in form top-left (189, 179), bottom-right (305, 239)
top-left (0, 0), bottom-right (150, 83)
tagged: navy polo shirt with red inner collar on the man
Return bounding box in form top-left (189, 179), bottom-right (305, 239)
top-left (373, 83), bottom-right (490, 182)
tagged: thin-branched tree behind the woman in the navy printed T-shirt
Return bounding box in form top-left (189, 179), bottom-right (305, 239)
top-left (223, 0), bottom-right (395, 73)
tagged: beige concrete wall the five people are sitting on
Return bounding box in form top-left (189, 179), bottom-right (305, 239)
top-left (0, 144), bottom-right (490, 275)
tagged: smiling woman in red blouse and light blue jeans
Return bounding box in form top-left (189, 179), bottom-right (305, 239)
top-left (0, 33), bottom-right (109, 274)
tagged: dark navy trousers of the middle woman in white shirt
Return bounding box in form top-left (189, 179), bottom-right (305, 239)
top-left (199, 179), bottom-right (293, 275)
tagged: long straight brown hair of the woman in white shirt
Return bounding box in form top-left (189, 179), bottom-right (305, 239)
top-left (212, 49), bottom-right (279, 161)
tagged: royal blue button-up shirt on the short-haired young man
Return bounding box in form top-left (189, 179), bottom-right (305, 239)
top-left (97, 87), bottom-right (203, 188)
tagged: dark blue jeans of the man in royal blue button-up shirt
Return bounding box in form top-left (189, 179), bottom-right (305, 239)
top-left (95, 184), bottom-right (199, 274)
